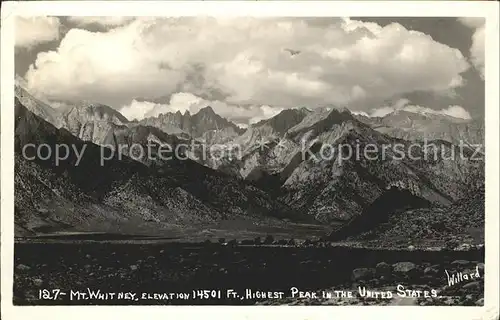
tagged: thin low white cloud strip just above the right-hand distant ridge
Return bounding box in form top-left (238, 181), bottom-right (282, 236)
top-left (353, 99), bottom-right (472, 120)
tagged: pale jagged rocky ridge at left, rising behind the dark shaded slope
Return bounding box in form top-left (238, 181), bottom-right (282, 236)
top-left (15, 85), bottom-right (243, 167)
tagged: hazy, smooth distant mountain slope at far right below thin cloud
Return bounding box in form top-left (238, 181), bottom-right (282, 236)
top-left (356, 110), bottom-right (484, 145)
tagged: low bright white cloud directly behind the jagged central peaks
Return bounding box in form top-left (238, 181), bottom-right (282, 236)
top-left (120, 92), bottom-right (283, 126)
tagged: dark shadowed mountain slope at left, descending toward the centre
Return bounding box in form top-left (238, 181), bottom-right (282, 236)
top-left (15, 99), bottom-right (309, 233)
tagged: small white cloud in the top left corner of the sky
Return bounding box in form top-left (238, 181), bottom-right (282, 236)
top-left (14, 16), bottom-right (61, 49)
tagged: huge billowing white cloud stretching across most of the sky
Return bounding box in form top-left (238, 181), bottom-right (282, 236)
top-left (22, 17), bottom-right (469, 120)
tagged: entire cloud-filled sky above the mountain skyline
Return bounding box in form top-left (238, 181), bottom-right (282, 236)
top-left (15, 17), bottom-right (484, 124)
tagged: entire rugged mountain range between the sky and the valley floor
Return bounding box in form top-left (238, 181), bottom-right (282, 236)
top-left (15, 83), bottom-right (484, 240)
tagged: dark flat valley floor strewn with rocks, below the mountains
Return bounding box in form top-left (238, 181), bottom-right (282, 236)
top-left (14, 239), bottom-right (484, 305)
